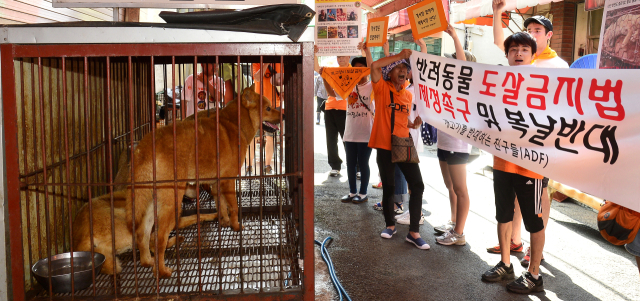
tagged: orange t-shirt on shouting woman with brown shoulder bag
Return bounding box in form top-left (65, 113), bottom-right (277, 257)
top-left (369, 79), bottom-right (413, 150)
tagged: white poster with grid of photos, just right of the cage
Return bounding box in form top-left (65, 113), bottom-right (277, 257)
top-left (315, 0), bottom-right (362, 56)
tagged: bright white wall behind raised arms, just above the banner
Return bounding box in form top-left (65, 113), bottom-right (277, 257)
top-left (442, 14), bottom-right (523, 65)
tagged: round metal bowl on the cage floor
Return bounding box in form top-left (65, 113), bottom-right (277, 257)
top-left (31, 252), bottom-right (105, 293)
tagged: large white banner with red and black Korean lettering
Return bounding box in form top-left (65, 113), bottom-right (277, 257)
top-left (411, 51), bottom-right (640, 211)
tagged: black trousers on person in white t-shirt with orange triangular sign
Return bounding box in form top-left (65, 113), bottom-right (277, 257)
top-left (344, 142), bottom-right (371, 195)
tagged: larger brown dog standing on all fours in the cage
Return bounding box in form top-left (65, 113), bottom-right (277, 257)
top-left (125, 86), bottom-right (280, 277)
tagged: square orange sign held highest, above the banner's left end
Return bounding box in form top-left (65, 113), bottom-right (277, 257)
top-left (407, 0), bottom-right (447, 40)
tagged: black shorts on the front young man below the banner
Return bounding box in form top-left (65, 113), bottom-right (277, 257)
top-left (493, 170), bottom-right (544, 233)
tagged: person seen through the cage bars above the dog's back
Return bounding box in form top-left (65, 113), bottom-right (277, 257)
top-left (184, 64), bottom-right (224, 117)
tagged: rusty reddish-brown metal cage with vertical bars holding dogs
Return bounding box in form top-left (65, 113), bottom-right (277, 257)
top-left (0, 42), bottom-right (314, 300)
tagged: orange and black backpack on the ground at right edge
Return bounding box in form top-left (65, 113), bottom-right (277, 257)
top-left (598, 201), bottom-right (640, 246)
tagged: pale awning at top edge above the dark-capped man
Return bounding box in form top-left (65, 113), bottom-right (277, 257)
top-left (451, 0), bottom-right (562, 23)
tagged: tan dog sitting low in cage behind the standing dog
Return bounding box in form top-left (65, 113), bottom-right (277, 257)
top-left (73, 190), bottom-right (218, 275)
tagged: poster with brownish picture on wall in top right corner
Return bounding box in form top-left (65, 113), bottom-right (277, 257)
top-left (597, 0), bottom-right (640, 69)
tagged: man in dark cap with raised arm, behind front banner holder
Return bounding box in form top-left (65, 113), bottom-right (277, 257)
top-left (487, 0), bottom-right (569, 267)
